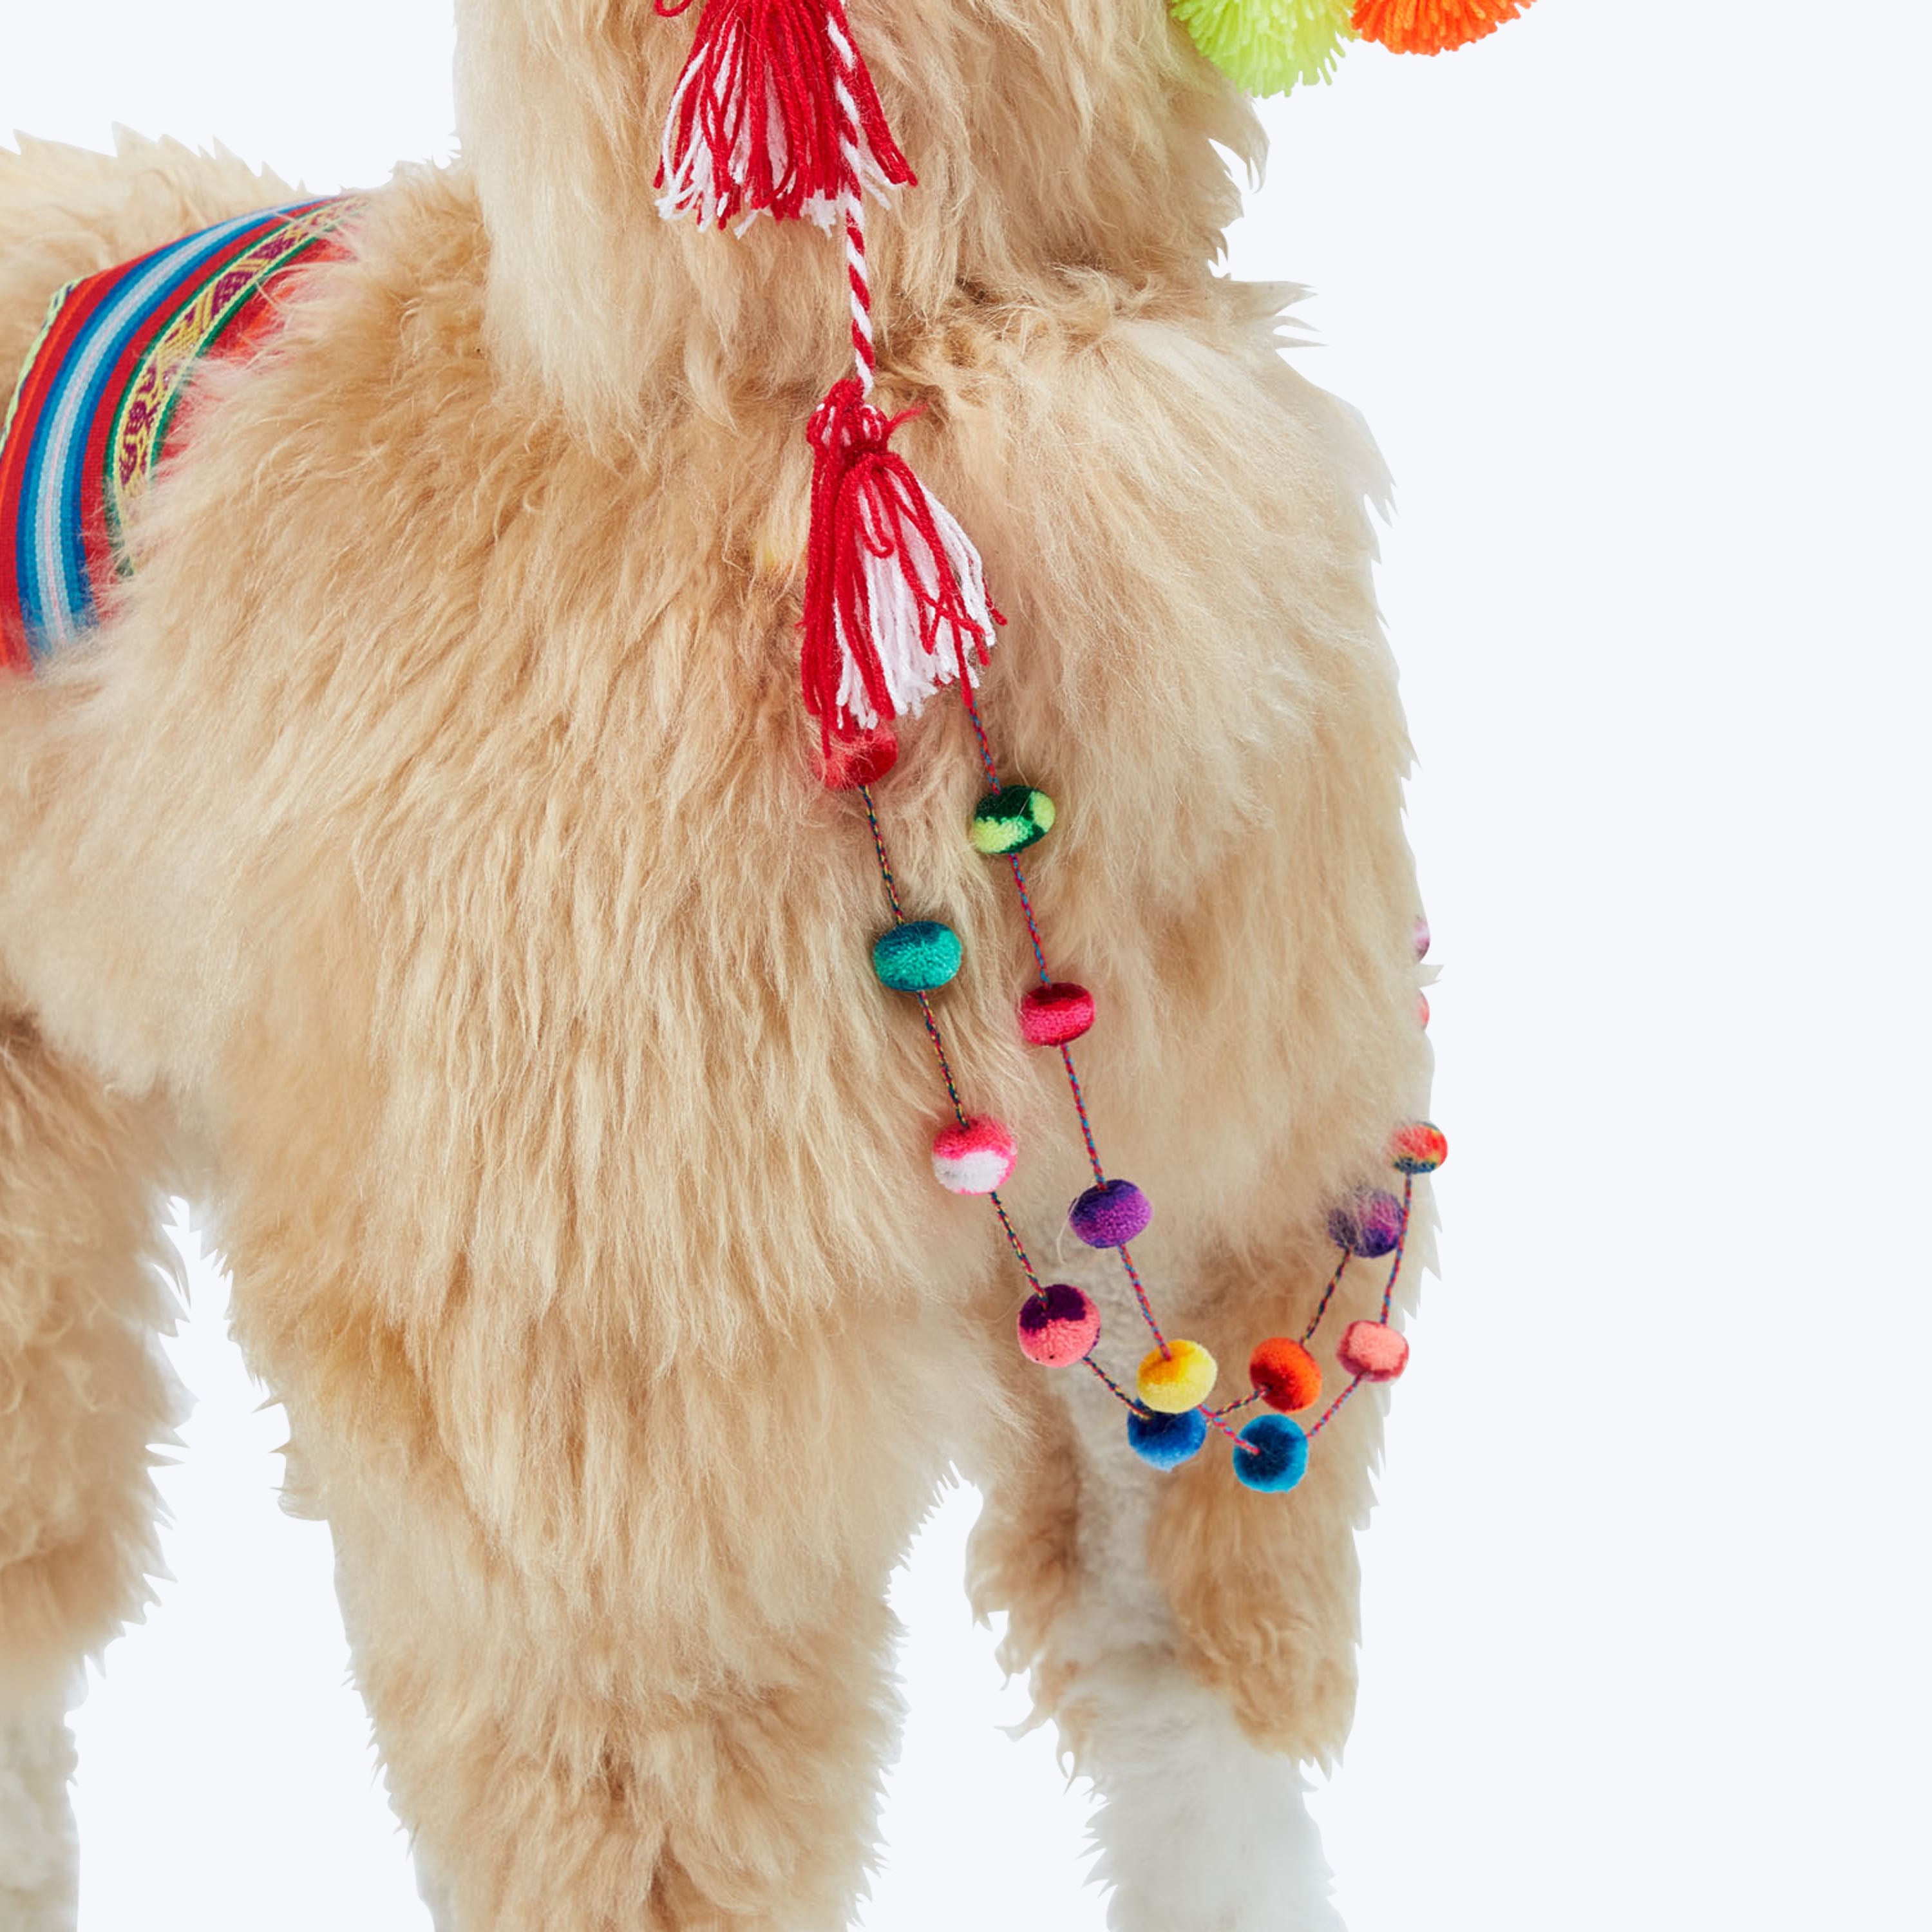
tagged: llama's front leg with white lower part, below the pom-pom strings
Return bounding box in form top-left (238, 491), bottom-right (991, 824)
top-left (974, 1202), bottom-right (1430, 1932)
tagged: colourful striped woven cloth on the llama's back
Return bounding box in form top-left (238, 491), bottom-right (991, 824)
top-left (0, 199), bottom-right (354, 670)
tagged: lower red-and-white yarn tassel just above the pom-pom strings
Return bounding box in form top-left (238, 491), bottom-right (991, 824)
top-left (802, 375), bottom-right (1007, 750)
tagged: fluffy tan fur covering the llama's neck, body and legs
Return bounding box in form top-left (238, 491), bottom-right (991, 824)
top-left (0, 0), bottom-right (1428, 1932)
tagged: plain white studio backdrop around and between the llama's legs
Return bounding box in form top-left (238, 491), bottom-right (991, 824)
top-left (0, 0), bottom-right (1932, 1932)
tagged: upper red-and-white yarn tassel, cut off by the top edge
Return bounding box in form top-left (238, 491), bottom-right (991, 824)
top-left (657, 0), bottom-right (914, 228)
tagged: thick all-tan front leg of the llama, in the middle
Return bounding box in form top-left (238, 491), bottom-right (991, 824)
top-left (251, 1283), bottom-right (958, 1932)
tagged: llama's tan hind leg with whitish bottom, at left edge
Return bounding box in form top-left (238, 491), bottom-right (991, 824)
top-left (0, 1014), bottom-right (176, 1932)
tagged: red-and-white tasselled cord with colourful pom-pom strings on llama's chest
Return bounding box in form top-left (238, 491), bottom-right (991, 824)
top-left (641, 0), bottom-right (1468, 1492)
